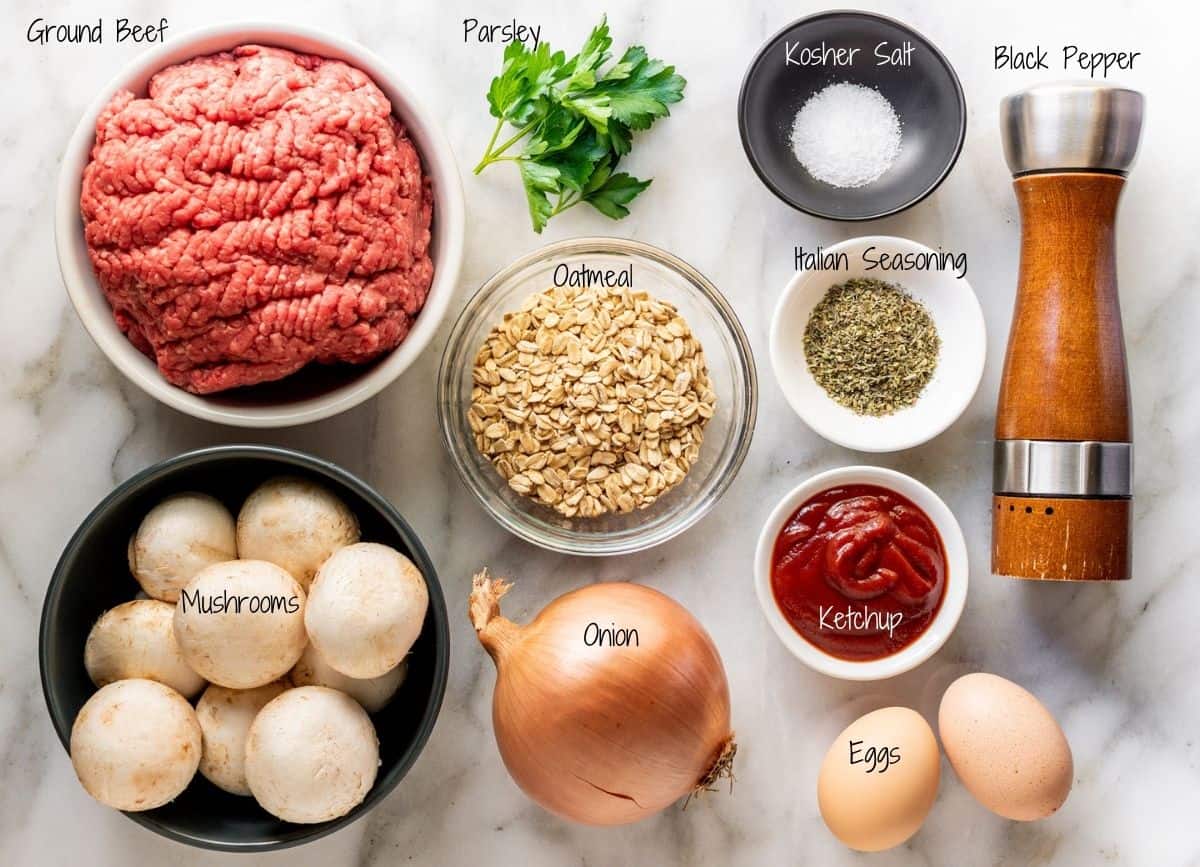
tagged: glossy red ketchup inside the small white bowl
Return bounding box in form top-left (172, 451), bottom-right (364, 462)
top-left (770, 485), bottom-right (946, 660)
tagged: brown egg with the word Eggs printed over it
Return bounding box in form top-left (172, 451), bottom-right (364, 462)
top-left (817, 707), bottom-right (941, 851)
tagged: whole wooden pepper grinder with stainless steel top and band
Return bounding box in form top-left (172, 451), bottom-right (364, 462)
top-left (991, 84), bottom-right (1142, 581)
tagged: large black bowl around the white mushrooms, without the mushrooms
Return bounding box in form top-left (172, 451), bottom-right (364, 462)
top-left (38, 446), bottom-right (450, 851)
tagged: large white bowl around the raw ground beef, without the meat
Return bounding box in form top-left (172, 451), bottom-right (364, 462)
top-left (54, 23), bottom-right (466, 427)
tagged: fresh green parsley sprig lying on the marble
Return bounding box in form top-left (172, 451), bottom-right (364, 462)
top-left (475, 17), bottom-right (688, 233)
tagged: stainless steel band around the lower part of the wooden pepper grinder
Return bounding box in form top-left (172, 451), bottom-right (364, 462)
top-left (992, 440), bottom-right (1133, 497)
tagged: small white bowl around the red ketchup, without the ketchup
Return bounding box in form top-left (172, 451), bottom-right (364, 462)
top-left (755, 466), bottom-right (968, 681)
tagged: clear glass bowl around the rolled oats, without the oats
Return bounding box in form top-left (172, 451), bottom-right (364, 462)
top-left (438, 238), bottom-right (758, 556)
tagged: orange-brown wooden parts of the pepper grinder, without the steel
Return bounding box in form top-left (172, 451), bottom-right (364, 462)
top-left (992, 172), bottom-right (1133, 581)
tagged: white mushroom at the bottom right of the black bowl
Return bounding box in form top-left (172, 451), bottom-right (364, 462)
top-left (246, 687), bottom-right (379, 823)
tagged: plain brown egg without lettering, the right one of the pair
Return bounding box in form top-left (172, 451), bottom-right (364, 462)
top-left (937, 672), bottom-right (1074, 821)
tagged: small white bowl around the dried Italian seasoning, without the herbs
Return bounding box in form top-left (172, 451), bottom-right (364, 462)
top-left (770, 235), bottom-right (988, 452)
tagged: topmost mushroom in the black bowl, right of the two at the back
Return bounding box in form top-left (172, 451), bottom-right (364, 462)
top-left (238, 476), bottom-right (359, 592)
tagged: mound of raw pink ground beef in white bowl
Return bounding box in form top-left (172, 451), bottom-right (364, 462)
top-left (79, 46), bottom-right (433, 394)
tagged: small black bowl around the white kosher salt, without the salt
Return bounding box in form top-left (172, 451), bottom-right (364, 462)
top-left (738, 11), bottom-right (967, 220)
